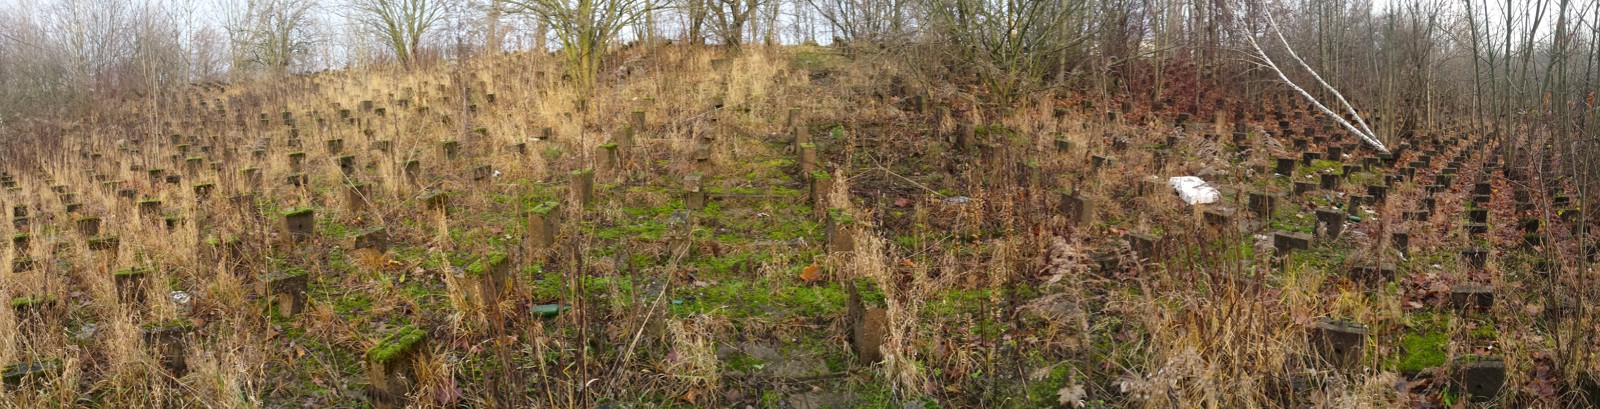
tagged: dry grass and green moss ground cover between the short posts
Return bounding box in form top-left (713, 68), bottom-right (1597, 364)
top-left (0, 48), bottom-right (1587, 407)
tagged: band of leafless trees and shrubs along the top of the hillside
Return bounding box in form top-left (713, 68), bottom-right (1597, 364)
top-left (0, 0), bottom-right (1600, 155)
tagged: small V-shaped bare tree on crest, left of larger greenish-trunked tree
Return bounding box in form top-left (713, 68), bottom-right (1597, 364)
top-left (350, 0), bottom-right (448, 67)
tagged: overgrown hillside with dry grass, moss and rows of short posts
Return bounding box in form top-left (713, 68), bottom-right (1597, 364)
top-left (0, 46), bottom-right (1595, 407)
